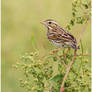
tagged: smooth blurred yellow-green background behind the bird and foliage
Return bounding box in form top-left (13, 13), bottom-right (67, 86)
top-left (2, 0), bottom-right (90, 92)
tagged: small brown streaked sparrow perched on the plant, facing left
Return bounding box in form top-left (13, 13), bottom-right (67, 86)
top-left (41, 19), bottom-right (79, 50)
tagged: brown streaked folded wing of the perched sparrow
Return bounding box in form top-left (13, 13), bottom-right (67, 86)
top-left (47, 28), bottom-right (76, 44)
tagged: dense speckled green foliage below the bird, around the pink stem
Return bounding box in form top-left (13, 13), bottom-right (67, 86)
top-left (15, 51), bottom-right (91, 92)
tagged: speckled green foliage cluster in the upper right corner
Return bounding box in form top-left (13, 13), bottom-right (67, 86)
top-left (66, 0), bottom-right (91, 30)
